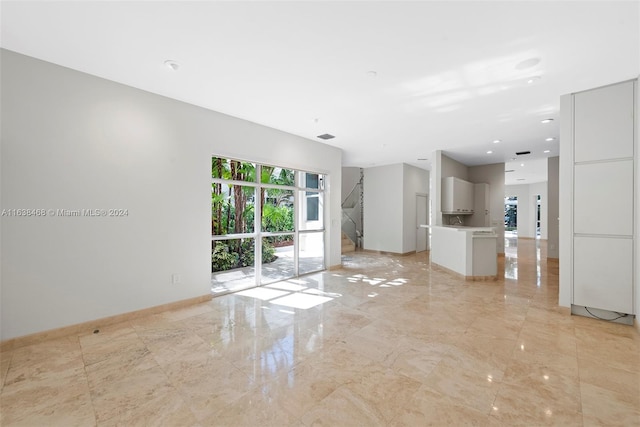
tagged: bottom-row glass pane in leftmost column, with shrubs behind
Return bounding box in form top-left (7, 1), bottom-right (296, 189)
top-left (211, 238), bottom-right (256, 294)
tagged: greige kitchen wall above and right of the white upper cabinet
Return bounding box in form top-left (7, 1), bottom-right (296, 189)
top-left (469, 163), bottom-right (504, 253)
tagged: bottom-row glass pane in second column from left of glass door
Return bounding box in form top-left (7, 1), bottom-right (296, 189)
top-left (260, 234), bottom-right (295, 284)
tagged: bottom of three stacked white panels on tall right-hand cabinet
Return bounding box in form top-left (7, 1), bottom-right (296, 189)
top-left (573, 237), bottom-right (633, 313)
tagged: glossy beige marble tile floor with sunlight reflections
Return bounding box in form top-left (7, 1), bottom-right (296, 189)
top-left (0, 239), bottom-right (640, 427)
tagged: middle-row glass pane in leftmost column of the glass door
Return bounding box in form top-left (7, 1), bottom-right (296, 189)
top-left (211, 183), bottom-right (255, 236)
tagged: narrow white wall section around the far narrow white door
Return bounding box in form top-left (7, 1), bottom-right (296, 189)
top-left (402, 164), bottom-right (429, 253)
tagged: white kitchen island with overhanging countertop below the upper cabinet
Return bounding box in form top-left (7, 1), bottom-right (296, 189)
top-left (421, 225), bottom-right (498, 280)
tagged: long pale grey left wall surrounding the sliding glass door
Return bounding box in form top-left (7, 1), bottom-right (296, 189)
top-left (1, 50), bottom-right (341, 340)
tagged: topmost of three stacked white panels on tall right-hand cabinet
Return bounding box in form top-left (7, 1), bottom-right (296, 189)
top-left (574, 81), bottom-right (634, 162)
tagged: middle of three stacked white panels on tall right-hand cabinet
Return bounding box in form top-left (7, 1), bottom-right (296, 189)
top-left (573, 160), bottom-right (633, 236)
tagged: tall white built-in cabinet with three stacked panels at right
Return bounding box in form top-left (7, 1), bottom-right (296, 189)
top-left (560, 80), bottom-right (639, 322)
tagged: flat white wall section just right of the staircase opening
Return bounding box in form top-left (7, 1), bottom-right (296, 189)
top-left (363, 164), bottom-right (404, 253)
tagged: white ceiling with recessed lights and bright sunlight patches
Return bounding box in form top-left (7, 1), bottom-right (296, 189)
top-left (0, 1), bottom-right (640, 183)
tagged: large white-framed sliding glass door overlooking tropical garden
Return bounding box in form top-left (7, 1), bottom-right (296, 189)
top-left (211, 157), bottom-right (325, 293)
